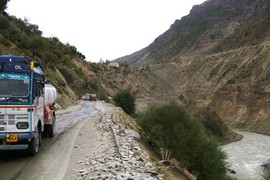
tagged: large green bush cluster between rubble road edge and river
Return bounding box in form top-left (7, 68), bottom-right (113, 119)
top-left (139, 102), bottom-right (226, 180)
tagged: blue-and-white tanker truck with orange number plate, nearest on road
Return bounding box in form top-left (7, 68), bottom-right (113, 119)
top-left (0, 54), bottom-right (57, 156)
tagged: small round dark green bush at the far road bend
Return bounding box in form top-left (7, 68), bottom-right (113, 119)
top-left (113, 90), bottom-right (135, 114)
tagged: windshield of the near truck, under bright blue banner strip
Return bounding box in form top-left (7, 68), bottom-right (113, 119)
top-left (0, 74), bottom-right (29, 98)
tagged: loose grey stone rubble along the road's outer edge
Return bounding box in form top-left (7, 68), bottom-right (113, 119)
top-left (77, 115), bottom-right (163, 180)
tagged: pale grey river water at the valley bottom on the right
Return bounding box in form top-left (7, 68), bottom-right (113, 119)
top-left (222, 131), bottom-right (270, 180)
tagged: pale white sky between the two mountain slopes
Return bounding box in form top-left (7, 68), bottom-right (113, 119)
top-left (7, 0), bottom-right (205, 62)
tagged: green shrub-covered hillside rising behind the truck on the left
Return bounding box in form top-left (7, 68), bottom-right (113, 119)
top-left (0, 0), bottom-right (112, 106)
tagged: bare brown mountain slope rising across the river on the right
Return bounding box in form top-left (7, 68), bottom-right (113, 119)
top-left (116, 0), bottom-right (270, 134)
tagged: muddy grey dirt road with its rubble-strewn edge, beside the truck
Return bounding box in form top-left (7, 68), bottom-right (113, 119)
top-left (0, 102), bottom-right (162, 180)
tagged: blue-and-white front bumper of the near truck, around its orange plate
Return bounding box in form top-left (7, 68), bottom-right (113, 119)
top-left (0, 132), bottom-right (35, 150)
